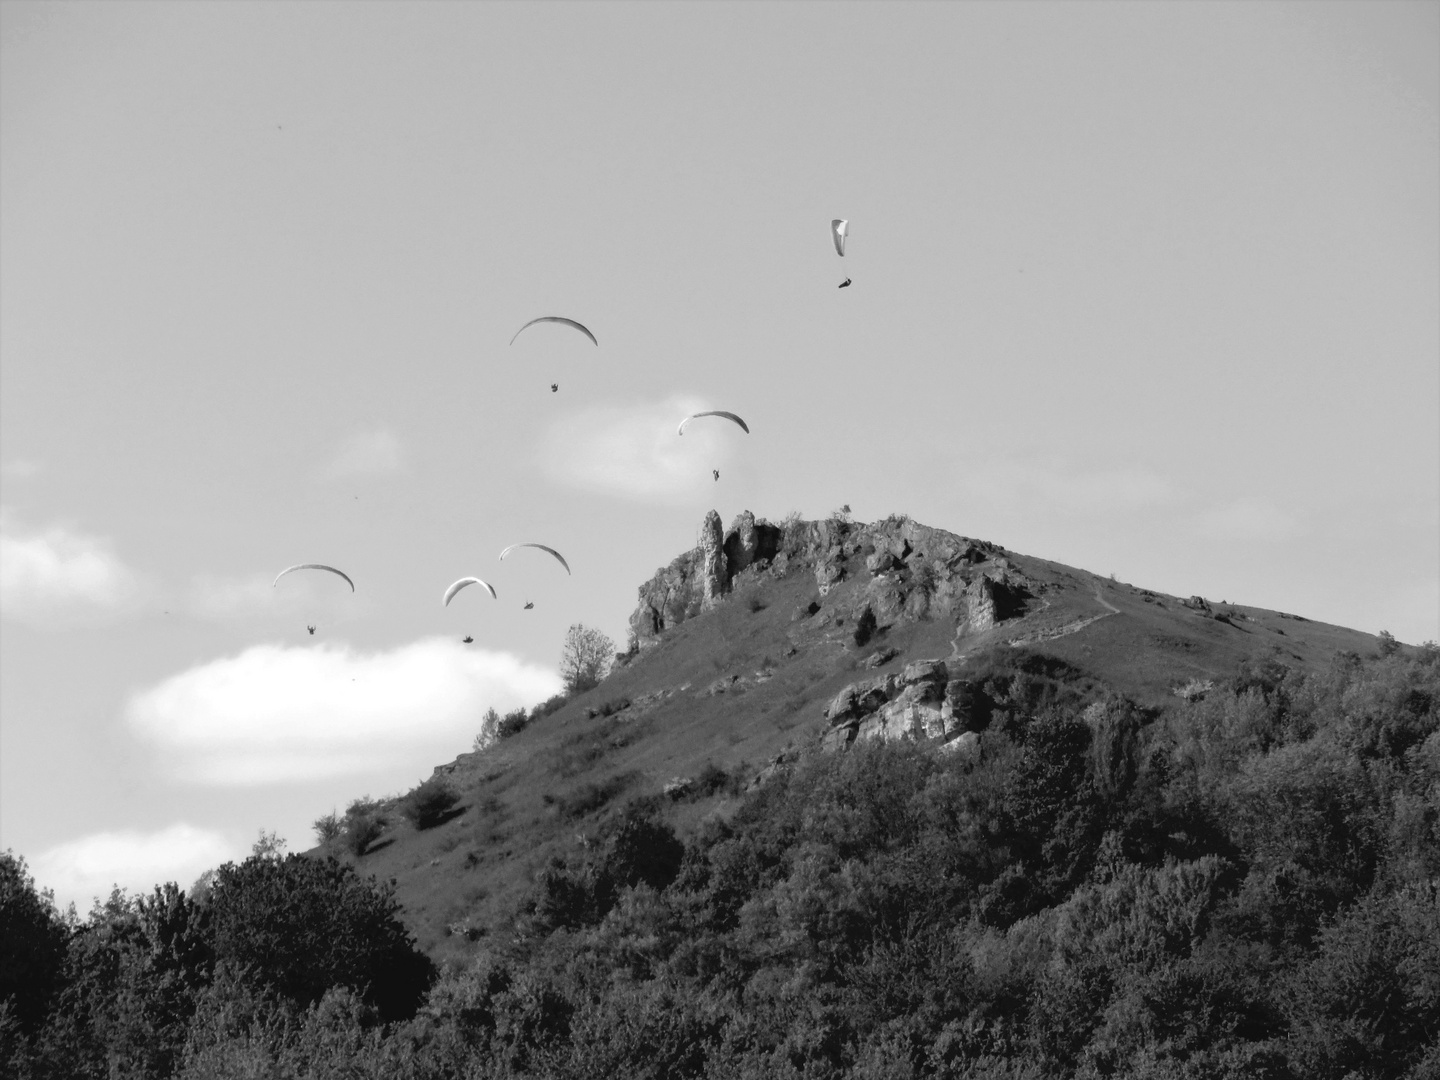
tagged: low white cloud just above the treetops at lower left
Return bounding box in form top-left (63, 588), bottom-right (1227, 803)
top-left (29, 824), bottom-right (237, 912)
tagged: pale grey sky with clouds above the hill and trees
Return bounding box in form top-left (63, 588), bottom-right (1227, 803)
top-left (0, 0), bottom-right (1440, 912)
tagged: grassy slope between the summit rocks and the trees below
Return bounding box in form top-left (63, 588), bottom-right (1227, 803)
top-left (312, 535), bottom-right (1375, 960)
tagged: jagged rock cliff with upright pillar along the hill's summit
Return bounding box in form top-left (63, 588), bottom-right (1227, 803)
top-left (629, 510), bottom-right (1030, 649)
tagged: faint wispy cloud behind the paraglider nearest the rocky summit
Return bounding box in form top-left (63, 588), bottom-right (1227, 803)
top-left (541, 397), bottom-right (746, 503)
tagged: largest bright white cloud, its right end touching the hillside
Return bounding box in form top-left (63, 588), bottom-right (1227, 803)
top-left (127, 638), bottom-right (560, 786)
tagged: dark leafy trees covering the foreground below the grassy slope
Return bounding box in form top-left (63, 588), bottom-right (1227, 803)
top-left (0, 648), bottom-right (1440, 1080)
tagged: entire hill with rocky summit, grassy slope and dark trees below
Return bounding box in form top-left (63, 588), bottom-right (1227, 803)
top-left (8, 514), bottom-right (1440, 1080)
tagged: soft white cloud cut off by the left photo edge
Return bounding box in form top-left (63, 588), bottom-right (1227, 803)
top-left (0, 516), bottom-right (145, 625)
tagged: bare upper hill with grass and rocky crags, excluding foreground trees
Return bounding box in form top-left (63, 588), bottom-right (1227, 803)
top-left (333, 511), bottom-right (1377, 962)
